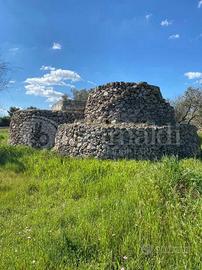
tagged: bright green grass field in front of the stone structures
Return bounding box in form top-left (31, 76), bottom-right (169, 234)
top-left (0, 130), bottom-right (202, 270)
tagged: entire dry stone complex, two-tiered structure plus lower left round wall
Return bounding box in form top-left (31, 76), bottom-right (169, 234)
top-left (10, 82), bottom-right (200, 160)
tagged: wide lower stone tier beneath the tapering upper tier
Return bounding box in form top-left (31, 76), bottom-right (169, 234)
top-left (55, 123), bottom-right (199, 160)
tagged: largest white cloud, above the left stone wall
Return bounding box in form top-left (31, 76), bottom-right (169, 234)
top-left (25, 66), bottom-right (81, 102)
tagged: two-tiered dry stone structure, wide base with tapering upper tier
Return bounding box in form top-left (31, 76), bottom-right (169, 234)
top-left (54, 82), bottom-right (200, 160)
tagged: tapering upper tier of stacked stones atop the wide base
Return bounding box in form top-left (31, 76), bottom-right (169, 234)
top-left (85, 82), bottom-right (175, 125)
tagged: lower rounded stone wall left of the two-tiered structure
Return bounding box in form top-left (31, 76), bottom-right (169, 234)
top-left (10, 110), bottom-right (84, 148)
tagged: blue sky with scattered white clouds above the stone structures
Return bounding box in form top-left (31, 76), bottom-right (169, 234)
top-left (0, 0), bottom-right (202, 113)
